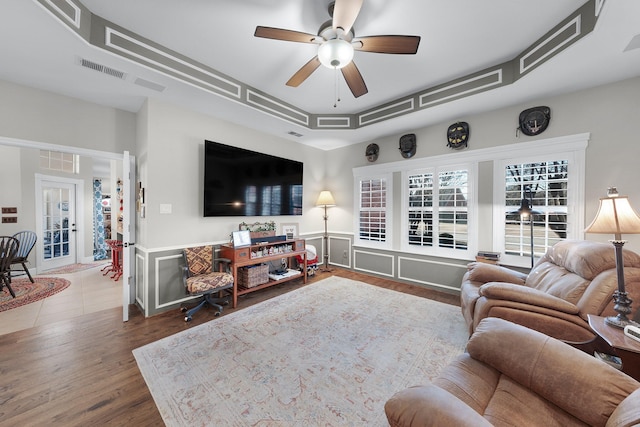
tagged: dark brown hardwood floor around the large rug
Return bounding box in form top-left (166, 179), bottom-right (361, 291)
top-left (0, 269), bottom-right (459, 426)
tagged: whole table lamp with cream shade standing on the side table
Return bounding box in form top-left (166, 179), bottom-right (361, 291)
top-left (584, 187), bottom-right (640, 328)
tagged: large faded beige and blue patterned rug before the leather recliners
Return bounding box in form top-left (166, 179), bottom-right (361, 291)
top-left (133, 277), bottom-right (467, 426)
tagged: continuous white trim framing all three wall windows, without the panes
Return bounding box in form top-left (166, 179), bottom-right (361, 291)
top-left (353, 133), bottom-right (591, 267)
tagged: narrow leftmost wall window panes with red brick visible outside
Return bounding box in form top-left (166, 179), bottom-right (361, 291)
top-left (358, 177), bottom-right (390, 243)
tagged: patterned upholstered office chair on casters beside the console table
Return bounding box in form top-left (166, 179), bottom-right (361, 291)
top-left (180, 246), bottom-right (233, 322)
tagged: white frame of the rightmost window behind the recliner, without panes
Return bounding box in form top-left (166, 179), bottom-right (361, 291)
top-left (493, 134), bottom-right (590, 267)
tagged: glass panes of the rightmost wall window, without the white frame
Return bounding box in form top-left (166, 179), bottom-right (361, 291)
top-left (504, 158), bottom-right (569, 257)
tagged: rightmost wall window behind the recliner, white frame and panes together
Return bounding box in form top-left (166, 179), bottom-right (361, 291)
top-left (493, 134), bottom-right (589, 267)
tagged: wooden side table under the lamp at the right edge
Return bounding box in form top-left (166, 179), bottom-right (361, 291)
top-left (588, 314), bottom-right (640, 381)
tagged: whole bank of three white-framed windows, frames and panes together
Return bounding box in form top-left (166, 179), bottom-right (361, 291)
top-left (353, 133), bottom-right (590, 260)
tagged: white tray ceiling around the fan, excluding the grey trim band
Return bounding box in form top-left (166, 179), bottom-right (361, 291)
top-left (0, 0), bottom-right (640, 149)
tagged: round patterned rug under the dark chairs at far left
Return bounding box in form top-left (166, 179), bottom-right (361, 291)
top-left (0, 277), bottom-right (71, 311)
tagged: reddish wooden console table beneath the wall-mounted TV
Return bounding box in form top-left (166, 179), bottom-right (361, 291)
top-left (220, 240), bottom-right (307, 308)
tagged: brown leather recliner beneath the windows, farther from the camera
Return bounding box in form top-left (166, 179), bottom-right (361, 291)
top-left (460, 240), bottom-right (640, 343)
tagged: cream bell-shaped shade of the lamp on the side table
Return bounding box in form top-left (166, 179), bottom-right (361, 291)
top-left (585, 193), bottom-right (640, 240)
